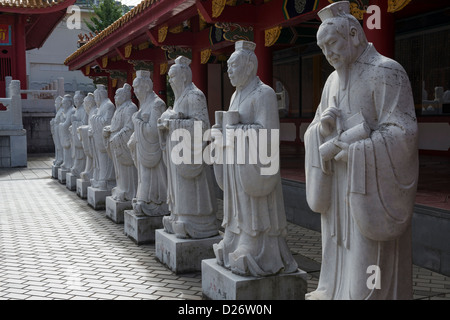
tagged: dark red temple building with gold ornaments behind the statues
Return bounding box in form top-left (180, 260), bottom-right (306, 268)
top-left (59, 0), bottom-right (450, 272)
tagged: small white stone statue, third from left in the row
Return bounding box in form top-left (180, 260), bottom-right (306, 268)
top-left (69, 91), bottom-right (88, 178)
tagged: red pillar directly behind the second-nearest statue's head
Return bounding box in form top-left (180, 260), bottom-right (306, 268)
top-left (254, 28), bottom-right (273, 87)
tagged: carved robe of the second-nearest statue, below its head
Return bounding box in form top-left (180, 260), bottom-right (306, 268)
top-left (214, 77), bottom-right (298, 276)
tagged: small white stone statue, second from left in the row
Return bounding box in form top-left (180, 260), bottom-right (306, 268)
top-left (59, 94), bottom-right (75, 171)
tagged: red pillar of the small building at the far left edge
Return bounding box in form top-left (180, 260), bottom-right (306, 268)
top-left (12, 14), bottom-right (27, 99)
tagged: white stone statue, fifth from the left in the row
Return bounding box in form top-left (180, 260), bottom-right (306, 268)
top-left (89, 84), bottom-right (116, 190)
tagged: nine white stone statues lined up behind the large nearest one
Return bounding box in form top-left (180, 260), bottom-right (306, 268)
top-left (53, 41), bottom-right (297, 282)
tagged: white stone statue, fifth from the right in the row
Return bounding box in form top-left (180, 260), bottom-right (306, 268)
top-left (103, 83), bottom-right (138, 202)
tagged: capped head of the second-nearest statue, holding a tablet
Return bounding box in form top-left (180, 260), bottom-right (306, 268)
top-left (227, 40), bottom-right (258, 88)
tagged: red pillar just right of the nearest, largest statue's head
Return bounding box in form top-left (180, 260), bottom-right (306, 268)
top-left (364, 0), bottom-right (395, 58)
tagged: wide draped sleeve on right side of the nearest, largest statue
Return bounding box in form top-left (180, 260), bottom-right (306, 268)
top-left (348, 63), bottom-right (418, 241)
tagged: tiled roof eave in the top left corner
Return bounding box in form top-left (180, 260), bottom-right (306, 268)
top-left (0, 0), bottom-right (76, 14)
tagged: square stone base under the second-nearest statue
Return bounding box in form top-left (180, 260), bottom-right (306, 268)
top-left (202, 258), bottom-right (307, 300)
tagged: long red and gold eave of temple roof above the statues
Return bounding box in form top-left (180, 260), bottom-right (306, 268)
top-left (64, 0), bottom-right (328, 70)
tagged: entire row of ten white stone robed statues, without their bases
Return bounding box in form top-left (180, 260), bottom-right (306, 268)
top-left (52, 1), bottom-right (417, 299)
